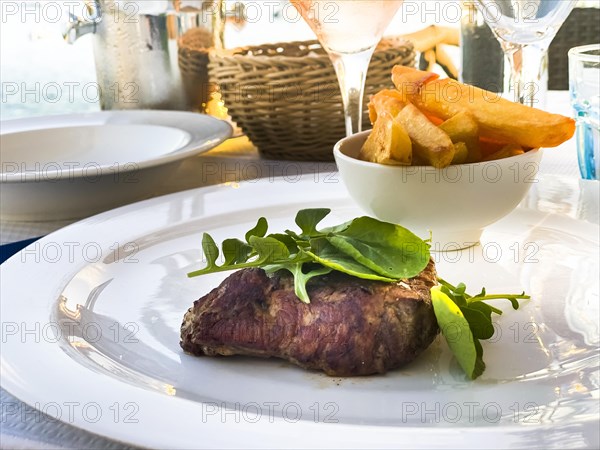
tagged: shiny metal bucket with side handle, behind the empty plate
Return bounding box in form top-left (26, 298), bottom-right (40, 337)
top-left (64, 0), bottom-right (225, 112)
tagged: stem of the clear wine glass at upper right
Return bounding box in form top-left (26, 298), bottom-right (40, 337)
top-left (504, 43), bottom-right (548, 108)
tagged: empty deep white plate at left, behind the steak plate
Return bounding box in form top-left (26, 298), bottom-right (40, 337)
top-left (0, 111), bottom-right (231, 221)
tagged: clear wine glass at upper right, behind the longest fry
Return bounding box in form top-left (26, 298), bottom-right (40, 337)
top-left (476, 0), bottom-right (577, 107)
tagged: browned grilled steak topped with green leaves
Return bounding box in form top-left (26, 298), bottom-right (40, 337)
top-left (181, 262), bottom-right (438, 376)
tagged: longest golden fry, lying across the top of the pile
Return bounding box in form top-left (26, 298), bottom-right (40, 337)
top-left (392, 66), bottom-right (575, 148)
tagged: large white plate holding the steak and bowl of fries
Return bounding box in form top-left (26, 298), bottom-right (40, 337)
top-left (0, 173), bottom-right (599, 448)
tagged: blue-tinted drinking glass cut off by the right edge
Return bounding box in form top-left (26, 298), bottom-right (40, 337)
top-left (569, 44), bottom-right (600, 180)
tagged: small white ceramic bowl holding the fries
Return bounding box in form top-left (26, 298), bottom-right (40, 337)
top-left (334, 131), bottom-right (542, 250)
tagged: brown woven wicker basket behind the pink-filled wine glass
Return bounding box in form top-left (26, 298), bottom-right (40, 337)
top-left (209, 39), bottom-right (415, 161)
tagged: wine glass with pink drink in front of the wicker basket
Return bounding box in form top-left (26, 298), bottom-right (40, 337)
top-left (291, 0), bottom-right (403, 136)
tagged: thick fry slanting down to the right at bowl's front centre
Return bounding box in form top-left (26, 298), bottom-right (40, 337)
top-left (396, 103), bottom-right (455, 168)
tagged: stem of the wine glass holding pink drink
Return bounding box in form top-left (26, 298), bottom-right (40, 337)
top-left (329, 47), bottom-right (375, 136)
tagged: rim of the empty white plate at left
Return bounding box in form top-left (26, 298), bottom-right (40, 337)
top-left (0, 110), bottom-right (233, 184)
